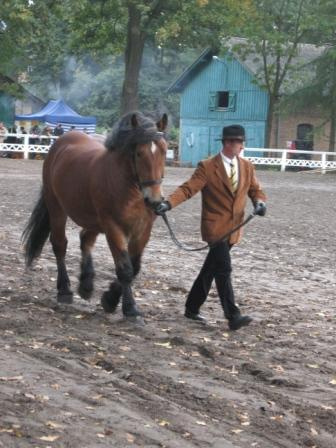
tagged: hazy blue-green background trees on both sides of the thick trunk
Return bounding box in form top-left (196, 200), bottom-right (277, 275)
top-left (63, 46), bottom-right (196, 129)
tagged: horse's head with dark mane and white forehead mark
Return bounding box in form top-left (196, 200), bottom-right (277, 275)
top-left (105, 112), bottom-right (168, 205)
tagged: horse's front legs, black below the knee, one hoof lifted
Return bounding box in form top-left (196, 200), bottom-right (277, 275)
top-left (102, 228), bottom-right (141, 318)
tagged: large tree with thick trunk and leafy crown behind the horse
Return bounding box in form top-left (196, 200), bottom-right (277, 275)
top-left (69, 0), bottom-right (248, 110)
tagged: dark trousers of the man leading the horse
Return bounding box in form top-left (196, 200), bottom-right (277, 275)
top-left (185, 241), bottom-right (240, 320)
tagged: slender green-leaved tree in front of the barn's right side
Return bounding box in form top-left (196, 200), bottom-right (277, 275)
top-left (230, 0), bottom-right (318, 147)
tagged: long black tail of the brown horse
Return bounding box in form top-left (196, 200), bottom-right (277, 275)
top-left (22, 189), bottom-right (50, 266)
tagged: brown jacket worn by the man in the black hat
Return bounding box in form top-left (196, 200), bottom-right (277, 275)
top-left (167, 154), bottom-right (266, 244)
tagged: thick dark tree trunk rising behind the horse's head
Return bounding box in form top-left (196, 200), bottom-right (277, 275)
top-left (120, 2), bottom-right (146, 114)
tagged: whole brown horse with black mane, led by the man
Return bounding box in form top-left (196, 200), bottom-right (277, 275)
top-left (23, 112), bottom-right (167, 319)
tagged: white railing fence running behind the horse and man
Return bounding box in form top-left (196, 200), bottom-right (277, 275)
top-left (0, 134), bottom-right (336, 173)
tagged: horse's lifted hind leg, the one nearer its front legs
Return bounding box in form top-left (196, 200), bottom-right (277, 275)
top-left (78, 229), bottom-right (97, 300)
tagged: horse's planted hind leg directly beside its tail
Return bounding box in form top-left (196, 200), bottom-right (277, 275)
top-left (49, 206), bottom-right (73, 303)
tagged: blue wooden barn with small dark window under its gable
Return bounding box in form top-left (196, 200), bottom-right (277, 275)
top-left (168, 49), bottom-right (268, 166)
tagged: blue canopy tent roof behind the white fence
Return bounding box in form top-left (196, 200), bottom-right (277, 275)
top-left (15, 100), bottom-right (96, 134)
